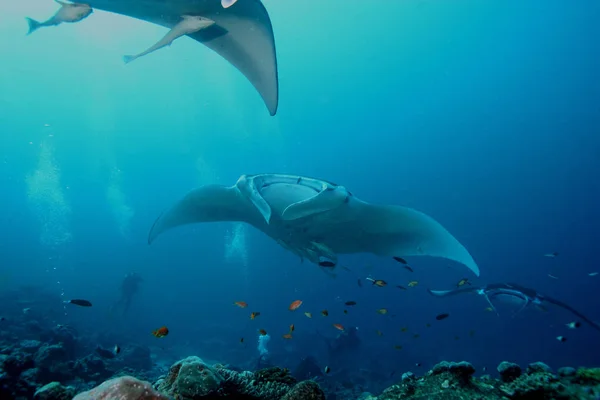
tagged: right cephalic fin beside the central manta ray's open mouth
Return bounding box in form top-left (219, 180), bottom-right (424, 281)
top-left (281, 186), bottom-right (349, 221)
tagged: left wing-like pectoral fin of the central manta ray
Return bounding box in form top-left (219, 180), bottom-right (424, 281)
top-left (148, 185), bottom-right (252, 243)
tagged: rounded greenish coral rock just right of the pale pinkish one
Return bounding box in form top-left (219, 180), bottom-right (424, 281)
top-left (158, 356), bottom-right (223, 399)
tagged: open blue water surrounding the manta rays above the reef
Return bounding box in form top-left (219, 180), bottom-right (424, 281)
top-left (0, 0), bottom-right (600, 394)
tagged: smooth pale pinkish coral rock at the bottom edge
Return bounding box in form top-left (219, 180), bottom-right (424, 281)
top-left (73, 376), bottom-right (169, 400)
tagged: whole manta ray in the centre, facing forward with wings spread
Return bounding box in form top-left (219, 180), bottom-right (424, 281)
top-left (148, 174), bottom-right (479, 275)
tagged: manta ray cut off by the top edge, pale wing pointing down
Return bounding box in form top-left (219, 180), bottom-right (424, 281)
top-left (82, 0), bottom-right (279, 115)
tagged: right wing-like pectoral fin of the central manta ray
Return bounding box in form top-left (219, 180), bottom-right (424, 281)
top-left (352, 199), bottom-right (479, 276)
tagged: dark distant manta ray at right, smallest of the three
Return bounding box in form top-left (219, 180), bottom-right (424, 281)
top-left (427, 283), bottom-right (600, 331)
